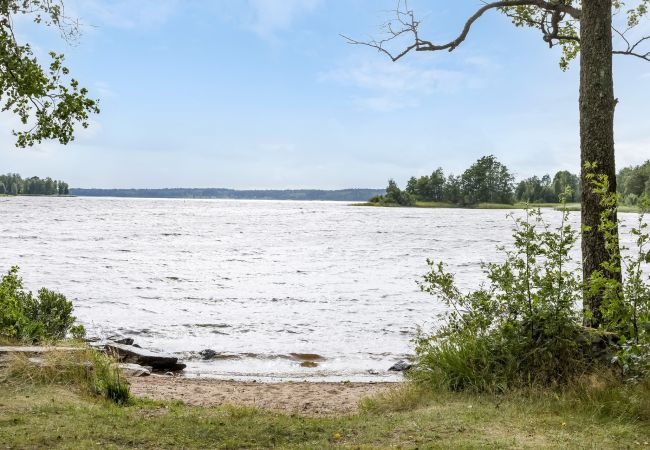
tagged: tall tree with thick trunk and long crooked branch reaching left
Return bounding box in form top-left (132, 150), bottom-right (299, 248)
top-left (344, 0), bottom-right (650, 326)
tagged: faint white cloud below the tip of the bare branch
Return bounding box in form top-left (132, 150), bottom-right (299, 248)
top-left (319, 60), bottom-right (480, 112)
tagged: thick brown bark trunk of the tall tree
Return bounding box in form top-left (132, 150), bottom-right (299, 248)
top-left (580, 0), bottom-right (621, 327)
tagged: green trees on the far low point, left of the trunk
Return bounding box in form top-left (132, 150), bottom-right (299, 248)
top-left (370, 155), bottom-right (580, 206)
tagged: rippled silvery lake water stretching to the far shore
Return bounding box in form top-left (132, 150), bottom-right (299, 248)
top-left (0, 197), bottom-right (636, 380)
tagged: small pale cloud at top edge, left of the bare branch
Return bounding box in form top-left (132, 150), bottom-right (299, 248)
top-left (247, 0), bottom-right (322, 39)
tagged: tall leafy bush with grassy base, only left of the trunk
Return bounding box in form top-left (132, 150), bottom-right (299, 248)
top-left (413, 197), bottom-right (595, 391)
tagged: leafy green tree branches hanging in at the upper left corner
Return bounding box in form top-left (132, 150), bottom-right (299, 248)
top-left (0, 0), bottom-right (99, 148)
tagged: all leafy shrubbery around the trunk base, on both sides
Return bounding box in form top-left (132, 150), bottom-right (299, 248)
top-left (412, 175), bottom-right (650, 391)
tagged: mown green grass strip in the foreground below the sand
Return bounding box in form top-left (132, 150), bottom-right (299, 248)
top-left (0, 362), bottom-right (650, 449)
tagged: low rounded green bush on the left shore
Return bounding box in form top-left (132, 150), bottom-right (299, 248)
top-left (0, 267), bottom-right (84, 342)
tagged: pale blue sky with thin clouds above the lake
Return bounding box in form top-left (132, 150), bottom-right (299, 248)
top-left (0, 0), bottom-right (650, 189)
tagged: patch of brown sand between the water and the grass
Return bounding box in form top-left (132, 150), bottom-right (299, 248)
top-left (124, 375), bottom-right (398, 416)
